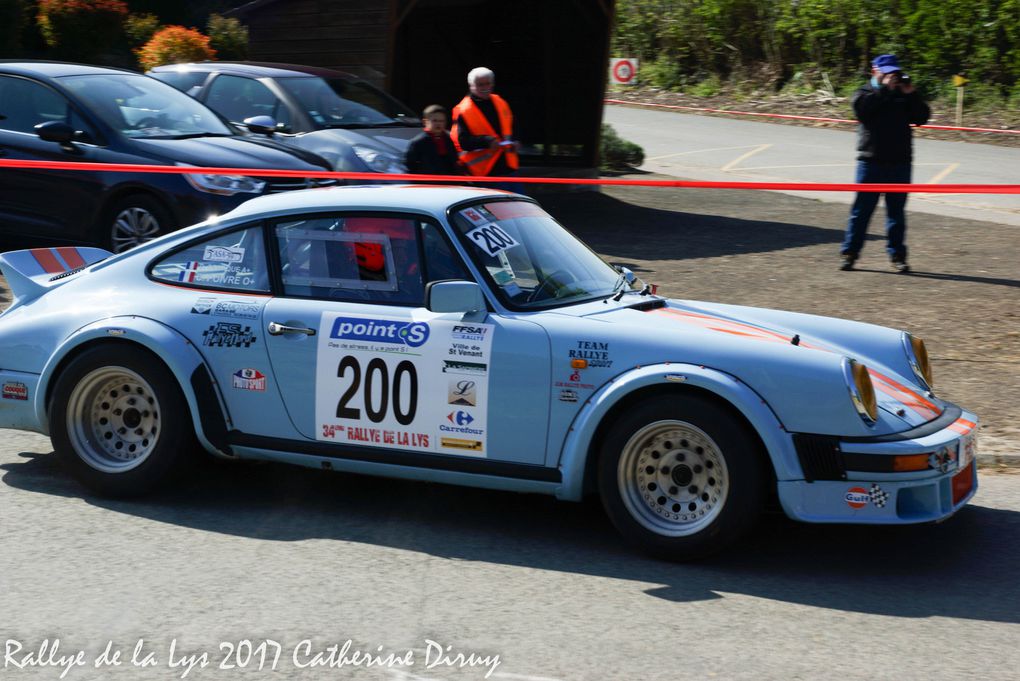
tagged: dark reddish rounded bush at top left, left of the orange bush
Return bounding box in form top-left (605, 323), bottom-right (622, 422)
top-left (37, 0), bottom-right (128, 62)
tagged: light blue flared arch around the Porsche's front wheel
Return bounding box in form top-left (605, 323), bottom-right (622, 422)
top-left (556, 363), bottom-right (803, 501)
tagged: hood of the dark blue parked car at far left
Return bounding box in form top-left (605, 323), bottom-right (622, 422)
top-left (133, 136), bottom-right (329, 170)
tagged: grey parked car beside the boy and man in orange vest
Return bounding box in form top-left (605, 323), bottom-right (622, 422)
top-left (149, 61), bottom-right (421, 172)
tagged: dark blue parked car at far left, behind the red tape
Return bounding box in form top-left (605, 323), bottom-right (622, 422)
top-left (0, 61), bottom-right (335, 252)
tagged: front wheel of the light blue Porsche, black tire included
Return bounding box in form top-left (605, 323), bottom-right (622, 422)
top-left (598, 395), bottom-right (771, 561)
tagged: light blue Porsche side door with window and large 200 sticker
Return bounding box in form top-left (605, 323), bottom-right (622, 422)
top-left (263, 212), bottom-right (550, 465)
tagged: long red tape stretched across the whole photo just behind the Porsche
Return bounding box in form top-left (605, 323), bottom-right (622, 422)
top-left (0, 159), bottom-right (1020, 194)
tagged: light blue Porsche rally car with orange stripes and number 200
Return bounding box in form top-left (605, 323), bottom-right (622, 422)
top-left (0, 186), bottom-right (977, 559)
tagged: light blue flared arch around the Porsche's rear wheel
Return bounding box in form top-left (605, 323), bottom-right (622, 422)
top-left (35, 316), bottom-right (231, 456)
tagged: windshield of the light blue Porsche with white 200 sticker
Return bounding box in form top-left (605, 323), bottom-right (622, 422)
top-left (453, 201), bottom-right (629, 309)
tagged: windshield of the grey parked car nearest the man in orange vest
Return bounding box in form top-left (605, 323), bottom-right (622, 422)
top-left (276, 77), bottom-right (419, 127)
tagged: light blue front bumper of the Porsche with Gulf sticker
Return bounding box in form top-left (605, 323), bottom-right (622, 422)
top-left (778, 412), bottom-right (978, 525)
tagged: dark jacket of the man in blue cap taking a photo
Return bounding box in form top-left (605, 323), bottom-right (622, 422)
top-left (853, 83), bottom-right (931, 164)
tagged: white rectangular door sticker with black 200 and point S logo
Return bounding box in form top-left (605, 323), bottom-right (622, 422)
top-left (315, 312), bottom-right (494, 457)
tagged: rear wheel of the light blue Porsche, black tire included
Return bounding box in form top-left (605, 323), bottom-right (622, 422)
top-left (49, 345), bottom-right (198, 497)
